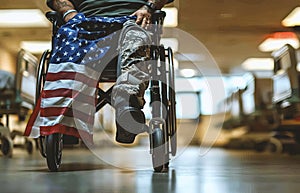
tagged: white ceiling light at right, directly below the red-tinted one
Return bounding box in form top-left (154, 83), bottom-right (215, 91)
top-left (242, 58), bottom-right (274, 71)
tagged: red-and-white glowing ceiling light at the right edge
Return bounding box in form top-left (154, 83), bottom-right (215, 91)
top-left (258, 32), bottom-right (299, 52)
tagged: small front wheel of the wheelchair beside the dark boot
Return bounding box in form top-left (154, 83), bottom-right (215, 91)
top-left (151, 128), bottom-right (168, 172)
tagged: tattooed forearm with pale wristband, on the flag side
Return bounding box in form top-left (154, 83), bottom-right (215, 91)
top-left (47, 0), bottom-right (77, 22)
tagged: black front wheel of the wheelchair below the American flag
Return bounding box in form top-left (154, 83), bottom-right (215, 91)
top-left (45, 133), bottom-right (63, 172)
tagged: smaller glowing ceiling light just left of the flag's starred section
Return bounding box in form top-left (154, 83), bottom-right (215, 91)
top-left (20, 41), bottom-right (51, 54)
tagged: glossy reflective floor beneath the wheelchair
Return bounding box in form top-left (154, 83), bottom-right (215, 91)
top-left (0, 147), bottom-right (300, 193)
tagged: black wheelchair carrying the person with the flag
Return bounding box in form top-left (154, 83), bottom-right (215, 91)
top-left (36, 11), bottom-right (177, 172)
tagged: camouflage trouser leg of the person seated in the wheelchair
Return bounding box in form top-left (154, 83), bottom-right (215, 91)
top-left (112, 20), bottom-right (151, 108)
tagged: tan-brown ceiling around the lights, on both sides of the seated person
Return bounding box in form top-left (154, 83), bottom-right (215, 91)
top-left (0, 0), bottom-right (299, 73)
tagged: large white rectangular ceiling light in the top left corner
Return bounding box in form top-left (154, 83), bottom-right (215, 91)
top-left (0, 9), bottom-right (50, 27)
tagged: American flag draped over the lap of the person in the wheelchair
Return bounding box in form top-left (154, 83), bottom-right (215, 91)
top-left (25, 13), bottom-right (134, 140)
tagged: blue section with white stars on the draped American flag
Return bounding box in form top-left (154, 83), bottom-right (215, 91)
top-left (52, 14), bottom-right (128, 66)
